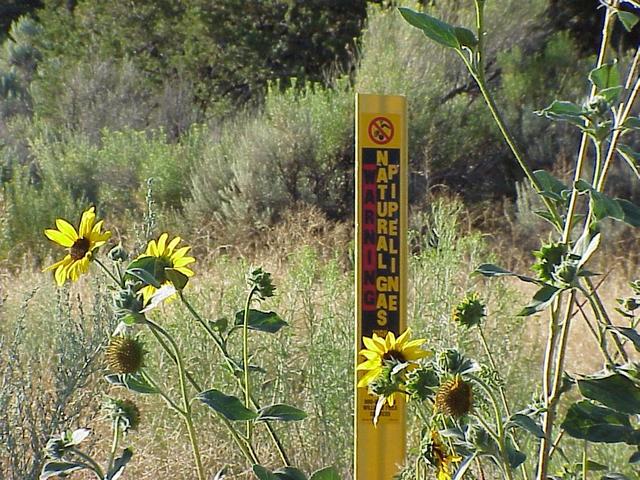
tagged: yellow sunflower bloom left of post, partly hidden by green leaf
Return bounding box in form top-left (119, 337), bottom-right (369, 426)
top-left (138, 233), bottom-right (196, 304)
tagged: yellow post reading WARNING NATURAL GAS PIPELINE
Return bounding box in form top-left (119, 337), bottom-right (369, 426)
top-left (354, 94), bottom-right (408, 480)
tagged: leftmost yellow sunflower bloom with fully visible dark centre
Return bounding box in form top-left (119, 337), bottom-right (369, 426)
top-left (44, 207), bottom-right (111, 286)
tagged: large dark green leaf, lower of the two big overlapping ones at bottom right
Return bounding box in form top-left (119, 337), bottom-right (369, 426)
top-left (561, 400), bottom-right (633, 443)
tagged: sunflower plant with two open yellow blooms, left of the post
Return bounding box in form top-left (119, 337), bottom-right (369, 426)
top-left (40, 207), bottom-right (339, 480)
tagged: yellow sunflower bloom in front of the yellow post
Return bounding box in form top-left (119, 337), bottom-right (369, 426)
top-left (356, 328), bottom-right (430, 406)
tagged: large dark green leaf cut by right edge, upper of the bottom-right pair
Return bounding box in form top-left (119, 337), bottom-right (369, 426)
top-left (577, 373), bottom-right (640, 415)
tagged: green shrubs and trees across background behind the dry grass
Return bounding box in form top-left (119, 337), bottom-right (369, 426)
top-left (0, 0), bottom-right (620, 257)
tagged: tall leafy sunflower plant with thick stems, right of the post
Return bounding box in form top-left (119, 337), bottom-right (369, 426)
top-left (360, 0), bottom-right (640, 480)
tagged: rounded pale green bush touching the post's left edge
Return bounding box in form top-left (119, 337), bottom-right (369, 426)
top-left (186, 81), bottom-right (353, 229)
